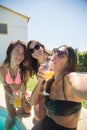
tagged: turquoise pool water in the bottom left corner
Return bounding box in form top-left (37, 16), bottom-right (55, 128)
top-left (0, 108), bottom-right (26, 130)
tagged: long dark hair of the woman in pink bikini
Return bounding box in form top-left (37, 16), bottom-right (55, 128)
top-left (4, 40), bottom-right (31, 79)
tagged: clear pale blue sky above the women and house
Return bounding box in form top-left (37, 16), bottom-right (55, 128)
top-left (0, 0), bottom-right (87, 51)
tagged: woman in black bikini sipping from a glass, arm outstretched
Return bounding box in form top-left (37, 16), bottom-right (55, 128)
top-left (30, 45), bottom-right (87, 130)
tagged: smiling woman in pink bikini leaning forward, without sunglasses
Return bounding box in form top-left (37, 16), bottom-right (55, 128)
top-left (0, 40), bottom-right (31, 130)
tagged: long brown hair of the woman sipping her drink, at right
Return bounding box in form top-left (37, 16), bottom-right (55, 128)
top-left (58, 45), bottom-right (77, 72)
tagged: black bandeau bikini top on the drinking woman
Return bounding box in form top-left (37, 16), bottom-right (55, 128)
top-left (46, 99), bottom-right (81, 116)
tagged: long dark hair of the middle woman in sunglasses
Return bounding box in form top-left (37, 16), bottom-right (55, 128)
top-left (27, 40), bottom-right (50, 74)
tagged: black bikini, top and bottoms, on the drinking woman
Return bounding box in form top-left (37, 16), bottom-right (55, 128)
top-left (42, 78), bottom-right (81, 130)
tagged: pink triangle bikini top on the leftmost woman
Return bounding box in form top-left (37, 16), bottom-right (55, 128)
top-left (6, 70), bottom-right (22, 85)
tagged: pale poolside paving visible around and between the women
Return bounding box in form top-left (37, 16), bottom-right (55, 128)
top-left (0, 85), bottom-right (87, 130)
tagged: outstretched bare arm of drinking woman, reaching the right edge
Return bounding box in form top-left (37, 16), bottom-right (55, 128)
top-left (69, 72), bottom-right (87, 100)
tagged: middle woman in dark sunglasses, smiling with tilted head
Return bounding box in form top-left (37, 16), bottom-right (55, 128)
top-left (27, 40), bottom-right (50, 123)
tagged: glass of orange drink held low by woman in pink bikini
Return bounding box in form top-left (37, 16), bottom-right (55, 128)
top-left (13, 90), bottom-right (21, 108)
